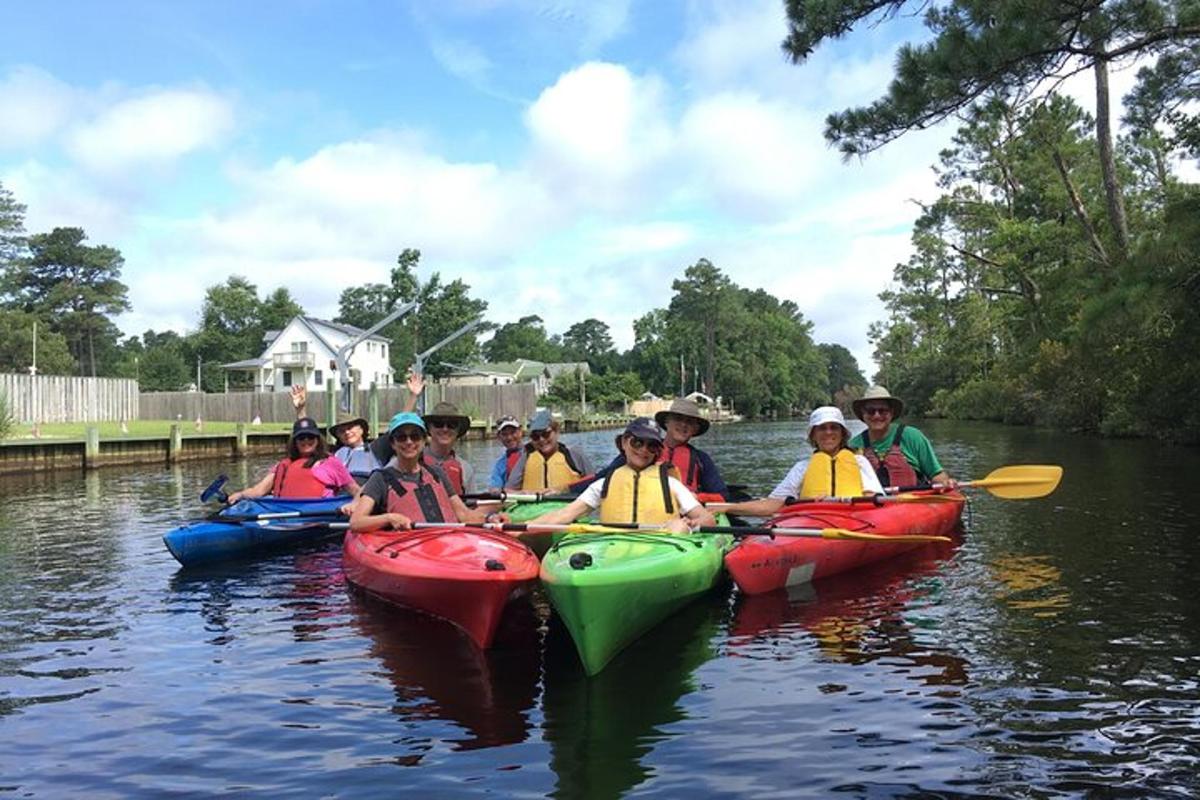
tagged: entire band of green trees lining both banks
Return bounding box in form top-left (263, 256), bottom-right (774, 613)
top-left (0, 0), bottom-right (1200, 443)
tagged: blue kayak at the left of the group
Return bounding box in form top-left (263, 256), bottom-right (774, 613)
top-left (162, 497), bottom-right (349, 566)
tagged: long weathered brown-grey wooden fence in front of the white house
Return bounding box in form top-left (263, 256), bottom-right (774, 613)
top-left (138, 384), bottom-right (538, 422)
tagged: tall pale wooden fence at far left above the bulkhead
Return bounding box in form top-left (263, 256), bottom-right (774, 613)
top-left (0, 373), bottom-right (138, 422)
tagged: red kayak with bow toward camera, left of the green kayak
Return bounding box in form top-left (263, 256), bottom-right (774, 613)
top-left (342, 528), bottom-right (540, 649)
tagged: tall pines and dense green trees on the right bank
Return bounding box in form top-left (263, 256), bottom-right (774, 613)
top-left (784, 0), bottom-right (1200, 441)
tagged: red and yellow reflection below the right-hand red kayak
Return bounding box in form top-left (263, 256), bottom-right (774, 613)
top-left (728, 545), bottom-right (968, 686)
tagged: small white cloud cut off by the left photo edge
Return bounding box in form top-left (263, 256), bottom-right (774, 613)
top-left (0, 66), bottom-right (77, 150)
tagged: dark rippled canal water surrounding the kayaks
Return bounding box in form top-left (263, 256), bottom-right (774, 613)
top-left (0, 423), bottom-right (1200, 798)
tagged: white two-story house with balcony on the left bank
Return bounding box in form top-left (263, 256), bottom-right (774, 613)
top-left (221, 317), bottom-right (392, 392)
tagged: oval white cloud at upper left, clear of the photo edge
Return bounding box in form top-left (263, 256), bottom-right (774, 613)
top-left (66, 89), bottom-right (234, 174)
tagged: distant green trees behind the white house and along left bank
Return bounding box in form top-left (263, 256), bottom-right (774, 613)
top-left (0, 185), bottom-right (865, 415)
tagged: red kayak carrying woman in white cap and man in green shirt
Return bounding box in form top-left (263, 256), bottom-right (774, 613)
top-left (725, 492), bottom-right (965, 595)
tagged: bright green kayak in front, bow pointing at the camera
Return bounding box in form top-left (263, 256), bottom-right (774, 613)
top-left (541, 523), bottom-right (733, 675)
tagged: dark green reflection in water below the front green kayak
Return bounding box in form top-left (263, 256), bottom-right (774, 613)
top-left (542, 593), bottom-right (727, 798)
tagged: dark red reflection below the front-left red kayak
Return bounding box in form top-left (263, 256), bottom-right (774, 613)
top-left (347, 588), bottom-right (541, 765)
